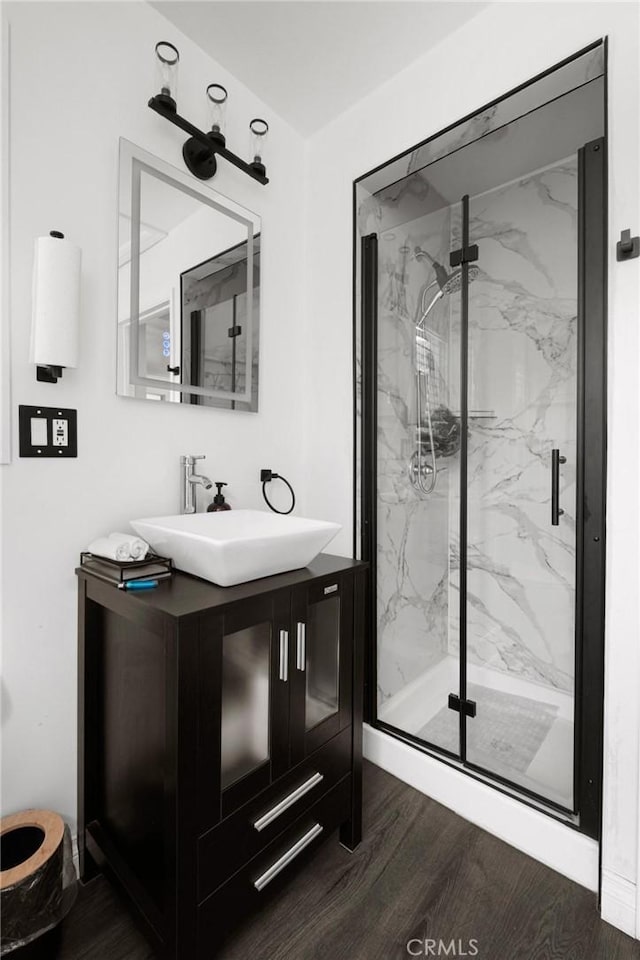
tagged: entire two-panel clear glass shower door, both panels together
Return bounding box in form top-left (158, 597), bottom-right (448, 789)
top-left (376, 161), bottom-right (578, 811)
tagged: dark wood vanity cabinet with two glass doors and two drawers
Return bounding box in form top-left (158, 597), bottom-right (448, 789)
top-left (78, 554), bottom-right (367, 960)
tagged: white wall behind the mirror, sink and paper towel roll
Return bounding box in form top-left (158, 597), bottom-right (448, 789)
top-left (2, 2), bottom-right (305, 821)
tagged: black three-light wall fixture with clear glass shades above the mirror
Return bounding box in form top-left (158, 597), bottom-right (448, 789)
top-left (149, 41), bottom-right (269, 184)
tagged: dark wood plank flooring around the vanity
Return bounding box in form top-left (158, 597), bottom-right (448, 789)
top-left (31, 764), bottom-right (640, 960)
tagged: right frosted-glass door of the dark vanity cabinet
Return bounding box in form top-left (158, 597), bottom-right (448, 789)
top-left (291, 578), bottom-right (353, 762)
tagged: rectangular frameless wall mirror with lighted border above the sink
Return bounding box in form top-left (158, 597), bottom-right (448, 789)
top-left (117, 140), bottom-right (260, 412)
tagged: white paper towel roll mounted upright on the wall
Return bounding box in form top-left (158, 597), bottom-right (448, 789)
top-left (29, 237), bottom-right (82, 367)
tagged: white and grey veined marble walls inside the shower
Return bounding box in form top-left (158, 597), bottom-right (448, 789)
top-left (376, 159), bottom-right (577, 704)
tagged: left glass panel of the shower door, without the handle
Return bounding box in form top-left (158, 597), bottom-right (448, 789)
top-left (376, 196), bottom-right (460, 757)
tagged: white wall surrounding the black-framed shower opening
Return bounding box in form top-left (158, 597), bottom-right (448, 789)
top-left (305, 3), bottom-right (640, 932)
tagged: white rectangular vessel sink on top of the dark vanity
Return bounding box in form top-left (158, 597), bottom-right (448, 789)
top-left (131, 510), bottom-right (342, 587)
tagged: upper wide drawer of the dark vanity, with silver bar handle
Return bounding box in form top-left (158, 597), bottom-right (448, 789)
top-left (198, 727), bottom-right (351, 902)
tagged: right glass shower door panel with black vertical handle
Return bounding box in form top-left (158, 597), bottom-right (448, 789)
top-left (466, 155), bottom-right (578, 810)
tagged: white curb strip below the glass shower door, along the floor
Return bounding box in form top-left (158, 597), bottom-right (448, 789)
top-left (364, 724), bottom-right (600, 892)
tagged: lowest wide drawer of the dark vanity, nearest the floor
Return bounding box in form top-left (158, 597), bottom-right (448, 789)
top-left (197, 775), bottom-right (351, 960)
